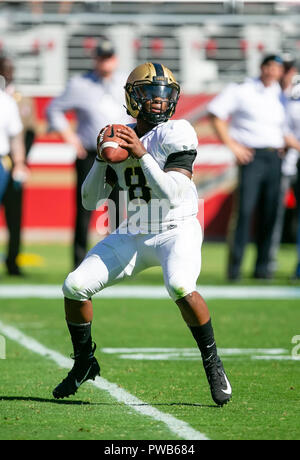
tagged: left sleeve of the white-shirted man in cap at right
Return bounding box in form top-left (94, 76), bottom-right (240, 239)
top-left (207, 83), bottom-right (238, 120)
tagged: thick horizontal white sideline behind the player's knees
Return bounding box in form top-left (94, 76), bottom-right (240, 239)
top-left (0, 284), bottom-right (300, 299)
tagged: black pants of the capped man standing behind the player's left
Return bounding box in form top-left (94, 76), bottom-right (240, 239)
top-left (73, 150), bottom-right (120, 268)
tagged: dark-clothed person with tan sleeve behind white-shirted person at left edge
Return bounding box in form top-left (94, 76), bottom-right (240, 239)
top-left (0, 56), bottom-right (34, 276)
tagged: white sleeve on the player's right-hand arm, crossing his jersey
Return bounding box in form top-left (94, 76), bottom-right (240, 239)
top-left (140, 153), bottom-right (191, 206)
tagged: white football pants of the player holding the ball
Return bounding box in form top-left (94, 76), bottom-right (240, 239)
top-left (63, 217), bottom-right (203, 301)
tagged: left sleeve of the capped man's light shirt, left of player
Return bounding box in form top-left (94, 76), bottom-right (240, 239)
top-left (46, 80), bottom-right (80, 131)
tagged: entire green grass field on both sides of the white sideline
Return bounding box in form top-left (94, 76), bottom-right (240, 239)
top-left (0, 244), bottom-right (300, 440)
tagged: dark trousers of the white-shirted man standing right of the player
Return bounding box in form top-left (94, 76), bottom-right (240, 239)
top-left (228, 148), bottom-right (281, 277)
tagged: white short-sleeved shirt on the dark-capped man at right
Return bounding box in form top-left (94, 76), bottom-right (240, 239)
top-left (207, 78), bottom-right (290, 148)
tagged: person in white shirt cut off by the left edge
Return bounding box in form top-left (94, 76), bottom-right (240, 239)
top-left (0, 58), bottom-right (28, 275)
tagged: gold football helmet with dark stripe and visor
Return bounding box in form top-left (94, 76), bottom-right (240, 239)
top-left (125, 62), bottom-right (180, 125)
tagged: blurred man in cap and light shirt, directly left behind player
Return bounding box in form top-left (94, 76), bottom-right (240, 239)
top-left (47, 36), bottom-right (131, 267)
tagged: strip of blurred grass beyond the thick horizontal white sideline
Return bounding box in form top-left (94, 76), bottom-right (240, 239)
top-left (0, 239), bottom-right (300, 285)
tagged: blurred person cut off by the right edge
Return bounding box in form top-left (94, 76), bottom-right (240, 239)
top-left (268, 57), bottom-right (300, 276)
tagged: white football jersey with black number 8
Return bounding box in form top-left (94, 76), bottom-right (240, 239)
top-left (111, 120), bottom-right (198, 231)
